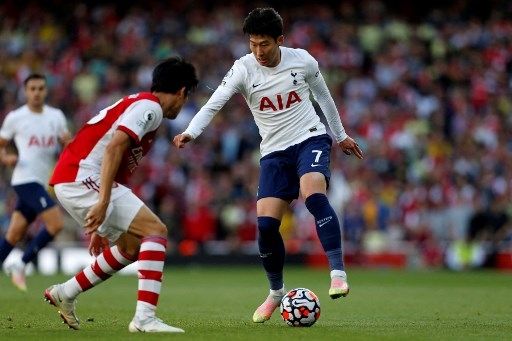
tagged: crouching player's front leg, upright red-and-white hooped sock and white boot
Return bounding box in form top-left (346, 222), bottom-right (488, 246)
top-left (127, 206), bottom-right (184, 333)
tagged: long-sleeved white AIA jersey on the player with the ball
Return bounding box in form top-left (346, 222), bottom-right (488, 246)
top-left (184, 47), bottom-right (347, 156)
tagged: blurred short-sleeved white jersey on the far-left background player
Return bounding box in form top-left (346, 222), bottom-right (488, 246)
top-left (0, 105), bottom-right (68, 186)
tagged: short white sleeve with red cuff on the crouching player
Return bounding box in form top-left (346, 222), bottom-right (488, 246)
top-left (117, 99), bottom-right (163, 142)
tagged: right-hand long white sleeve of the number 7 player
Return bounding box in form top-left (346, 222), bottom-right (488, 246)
top-left (305, 52), bottom-right (348, 142)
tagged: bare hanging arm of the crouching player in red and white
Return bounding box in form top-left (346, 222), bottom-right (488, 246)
top-left (85, 130), bottom-right (131, 234)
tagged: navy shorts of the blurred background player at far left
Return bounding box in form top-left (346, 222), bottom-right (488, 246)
top-left (13, 182), bottom-right (55, 224)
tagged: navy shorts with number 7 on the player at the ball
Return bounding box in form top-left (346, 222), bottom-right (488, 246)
top-left (258, 134), bottom-right (332, 201)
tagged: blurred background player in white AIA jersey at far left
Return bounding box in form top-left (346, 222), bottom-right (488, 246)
top-left (0, 74), bottom-right (71, 291)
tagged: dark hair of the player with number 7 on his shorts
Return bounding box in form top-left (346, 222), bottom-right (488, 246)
top-left (243, 7), bottom-right (283, 39)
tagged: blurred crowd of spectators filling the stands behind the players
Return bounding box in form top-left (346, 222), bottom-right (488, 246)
top-left (0, 0), bottom-right (512, 268)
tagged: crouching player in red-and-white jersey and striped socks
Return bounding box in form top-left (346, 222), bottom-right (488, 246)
top-left (44, 58), bottom-right (198, 333)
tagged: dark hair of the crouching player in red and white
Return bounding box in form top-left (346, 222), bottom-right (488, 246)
top-left (151, 57), bottom-right (198, 95)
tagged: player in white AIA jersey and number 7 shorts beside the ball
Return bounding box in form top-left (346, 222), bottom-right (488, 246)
top-left (173, 8), bottom-right (363, 323)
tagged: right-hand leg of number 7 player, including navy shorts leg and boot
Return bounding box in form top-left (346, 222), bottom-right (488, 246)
top-left (299, 136), bottom-right (349, 299)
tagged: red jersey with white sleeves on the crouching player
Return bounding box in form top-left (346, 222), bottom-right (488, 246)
top-left (50, 92), bottom-right (163, 185)
